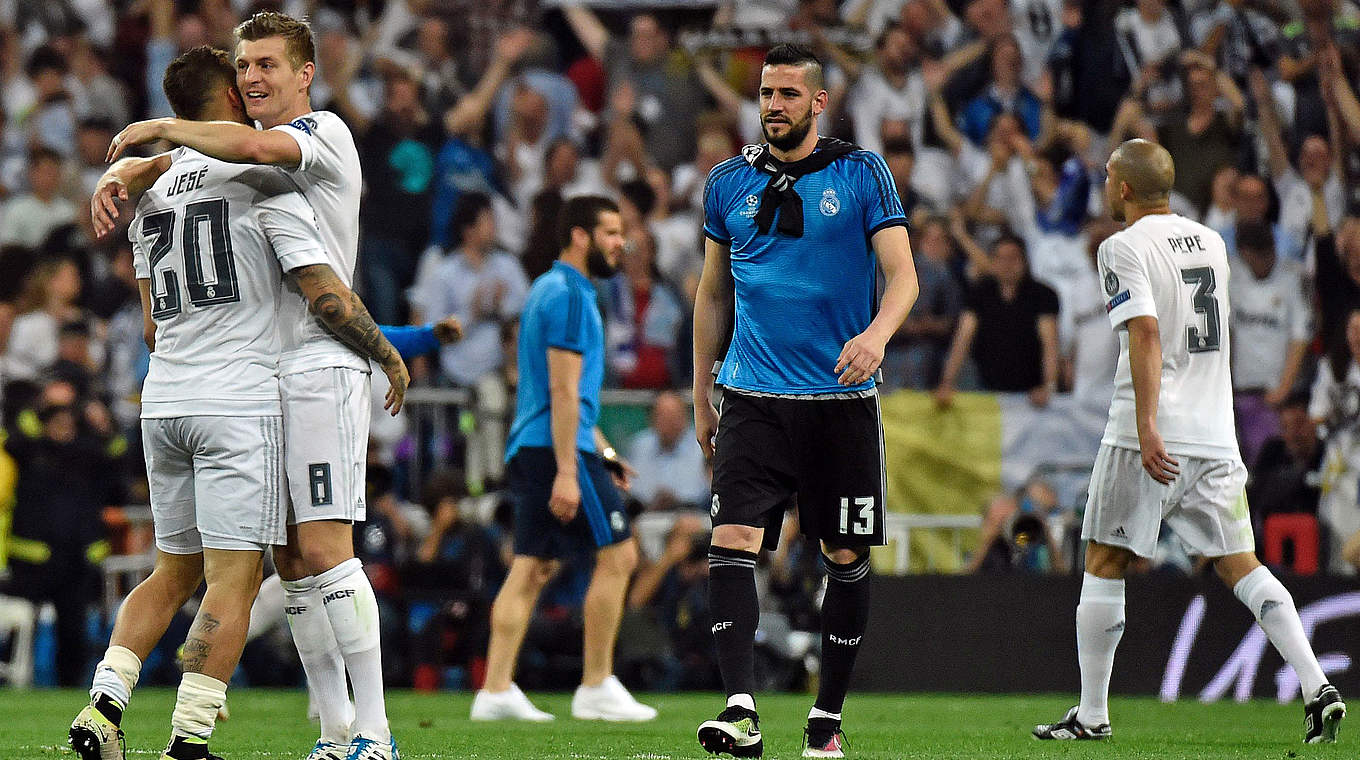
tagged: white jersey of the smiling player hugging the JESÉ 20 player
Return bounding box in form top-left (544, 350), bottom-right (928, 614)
top-left (273, 111), bottom-right (369, 375)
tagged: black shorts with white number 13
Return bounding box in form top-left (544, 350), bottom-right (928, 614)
top-left (713, 390), bottom-right (887, 548)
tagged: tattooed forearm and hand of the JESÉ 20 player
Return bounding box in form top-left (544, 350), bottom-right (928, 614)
top-left (288, 264), bottom-right (411, 415)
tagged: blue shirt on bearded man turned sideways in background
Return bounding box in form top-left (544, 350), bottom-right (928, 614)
top-left (506, 261), bottom-right (604, 461)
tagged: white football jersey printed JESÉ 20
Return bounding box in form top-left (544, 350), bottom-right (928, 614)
top-left (128, 148), bottom-right (328, 419)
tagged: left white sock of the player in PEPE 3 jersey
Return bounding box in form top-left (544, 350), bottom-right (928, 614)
top-left (1077, 572), bottom-right (1123, 727)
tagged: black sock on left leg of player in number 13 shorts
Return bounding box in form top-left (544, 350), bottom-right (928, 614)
top-left (709, 547), bottom-right (760, 699)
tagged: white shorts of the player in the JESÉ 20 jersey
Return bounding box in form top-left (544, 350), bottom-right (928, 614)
top-left (141, 416), bottom-right (287, 555)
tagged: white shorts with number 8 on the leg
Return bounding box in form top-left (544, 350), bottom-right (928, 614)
top-left (279, 367), bottom-right (371, 525)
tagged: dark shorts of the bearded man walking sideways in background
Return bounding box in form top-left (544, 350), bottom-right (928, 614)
top-left (509, 446), bottom-right (632, 559)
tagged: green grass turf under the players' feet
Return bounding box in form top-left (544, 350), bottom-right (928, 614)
top-left (0, 689), bottom-right (1343, 760)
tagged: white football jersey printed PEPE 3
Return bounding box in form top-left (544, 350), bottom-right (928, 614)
top-left (1099, 213), bottom-right (1242, 460)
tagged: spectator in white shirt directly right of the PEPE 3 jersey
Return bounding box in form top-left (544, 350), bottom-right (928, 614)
top-left (1229, 222), bottom-right (1312, 462)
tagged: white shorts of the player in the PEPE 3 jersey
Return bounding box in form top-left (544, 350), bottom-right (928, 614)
top-left (1081, 443), bottom-right (1255, 557)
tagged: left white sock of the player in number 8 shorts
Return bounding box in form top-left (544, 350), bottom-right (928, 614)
top-left (283, 575), bottom-right (354, 744)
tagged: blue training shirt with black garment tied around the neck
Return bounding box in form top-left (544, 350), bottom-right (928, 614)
top-left (703, 143), bottom-right (907, 396)
